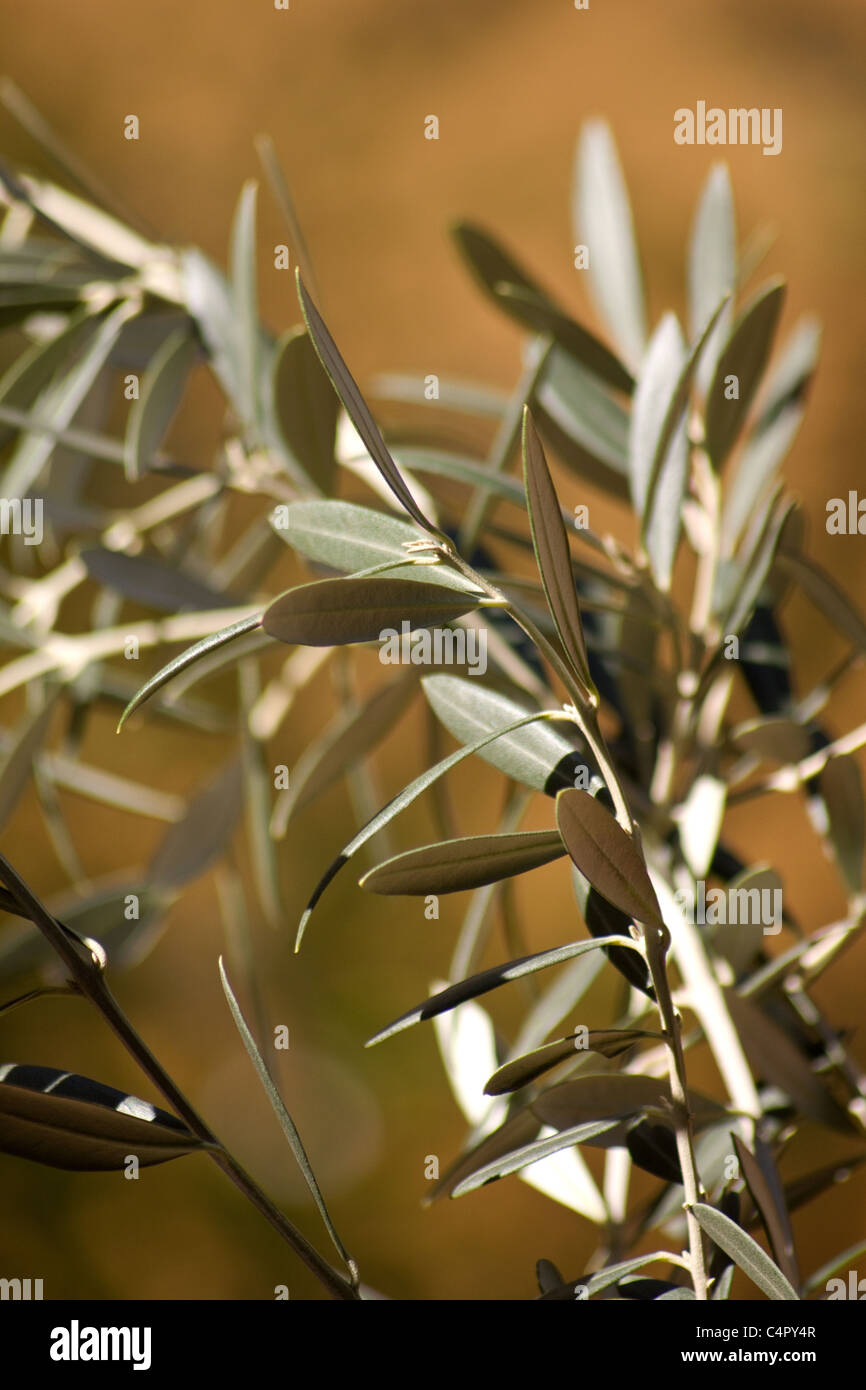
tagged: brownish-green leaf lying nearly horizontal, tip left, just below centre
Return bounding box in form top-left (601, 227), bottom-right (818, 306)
top-left (360, 830), bottom-right (566, 897)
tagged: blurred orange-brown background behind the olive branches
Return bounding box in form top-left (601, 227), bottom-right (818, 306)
top-left (0, 0), bottom-right (866, 1300)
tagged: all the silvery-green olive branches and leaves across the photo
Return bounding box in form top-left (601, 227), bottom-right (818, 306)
top-left (0, 89), bottom-right (866, 1300)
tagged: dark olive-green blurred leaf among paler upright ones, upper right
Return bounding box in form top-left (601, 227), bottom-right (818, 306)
top-left (706, 281), bottom-right (785, 468)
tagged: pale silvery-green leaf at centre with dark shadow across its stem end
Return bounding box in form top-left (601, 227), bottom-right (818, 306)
top-left (421, 676), bottom-right (587, 795)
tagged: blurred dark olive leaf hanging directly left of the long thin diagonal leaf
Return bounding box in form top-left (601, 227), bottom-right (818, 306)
top-left (271, 331), bottom-right (339, 492)
